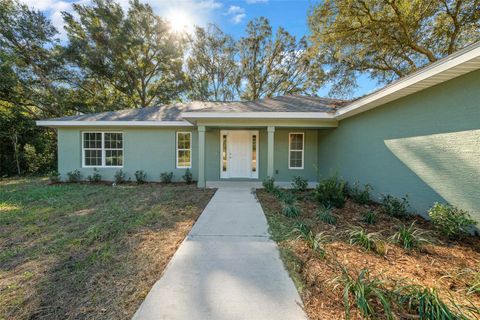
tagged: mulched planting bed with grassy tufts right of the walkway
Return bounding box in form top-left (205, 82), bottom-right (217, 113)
top-left (257, 188), bottom-right (480, 320)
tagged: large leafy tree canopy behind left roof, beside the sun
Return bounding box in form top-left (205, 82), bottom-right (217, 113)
top-left (64, 0), bottom-right (188, 108)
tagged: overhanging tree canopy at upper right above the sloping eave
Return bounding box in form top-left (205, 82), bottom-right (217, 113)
top-left (308, 0), bottom-right (480, 94)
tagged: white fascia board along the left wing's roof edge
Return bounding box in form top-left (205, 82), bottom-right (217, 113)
top-left (36, 120), bottom-right (193, 127)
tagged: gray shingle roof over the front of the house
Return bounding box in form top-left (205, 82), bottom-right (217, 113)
top-left (49, 95), bottom-right (348, 121)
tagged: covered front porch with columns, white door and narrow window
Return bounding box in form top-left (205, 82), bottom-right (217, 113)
top-left (182, 112), bottom-right (338, 188)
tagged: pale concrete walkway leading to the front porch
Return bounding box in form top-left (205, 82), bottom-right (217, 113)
top-left (133, 187), bottom-right (306, 320)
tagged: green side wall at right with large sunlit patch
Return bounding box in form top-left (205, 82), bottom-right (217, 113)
top-left (318, 71), bottom-right (480, 221)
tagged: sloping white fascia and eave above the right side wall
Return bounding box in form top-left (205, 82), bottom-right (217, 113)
top-left (335, 42), bottom-right (480, 120)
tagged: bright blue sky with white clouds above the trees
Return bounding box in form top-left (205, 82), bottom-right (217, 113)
top-left (18, 0), bottom-right (378, 96)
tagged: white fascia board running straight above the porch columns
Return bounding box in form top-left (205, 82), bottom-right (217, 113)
top-left (181, 111), bottom-right (335, 120)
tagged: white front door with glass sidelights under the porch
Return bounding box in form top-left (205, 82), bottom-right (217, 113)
top-left (220, 130), bottom-right (258, 178)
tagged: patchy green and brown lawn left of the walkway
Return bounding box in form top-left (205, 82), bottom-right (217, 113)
top-left (0, 178), bottom-right (214, 320)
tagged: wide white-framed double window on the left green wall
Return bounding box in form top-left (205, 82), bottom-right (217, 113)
top-left (82, 132), bottom-right (123, 167)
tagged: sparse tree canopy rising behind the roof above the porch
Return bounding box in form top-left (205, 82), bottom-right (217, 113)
top-left (238, 17), bottom-right (323, 100)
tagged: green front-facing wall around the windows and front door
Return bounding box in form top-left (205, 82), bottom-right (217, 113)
top-left (58, 127), bottom-right (318, 182)
